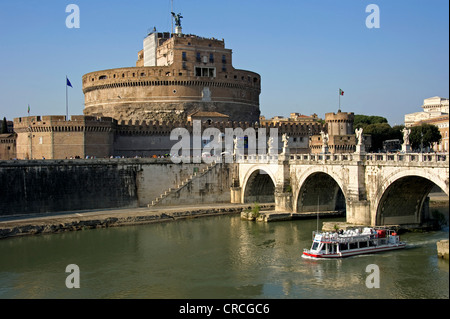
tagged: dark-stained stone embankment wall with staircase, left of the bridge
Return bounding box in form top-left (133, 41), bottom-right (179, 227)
top-left (0, 158), bottom-right (231, 216)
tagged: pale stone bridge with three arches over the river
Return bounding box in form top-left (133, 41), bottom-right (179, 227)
top-left (231, 153), bottom-right (449, 226)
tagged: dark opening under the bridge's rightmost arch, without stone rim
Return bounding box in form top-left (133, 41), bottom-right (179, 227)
top-left (376, 176), bottom-right (448, 225)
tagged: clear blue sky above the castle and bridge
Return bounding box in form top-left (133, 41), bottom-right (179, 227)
top-left (0, 0), bottom-right (449, 125)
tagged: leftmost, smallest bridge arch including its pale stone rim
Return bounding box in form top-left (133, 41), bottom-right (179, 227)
top-left (241, 165), bottom-right (276, 203)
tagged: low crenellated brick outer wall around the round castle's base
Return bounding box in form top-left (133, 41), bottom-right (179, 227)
top-left (12, 115), bottom-right (323, 159)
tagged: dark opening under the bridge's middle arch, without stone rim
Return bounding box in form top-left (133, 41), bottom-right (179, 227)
top-left (297, 172), bottom-right (346, 213)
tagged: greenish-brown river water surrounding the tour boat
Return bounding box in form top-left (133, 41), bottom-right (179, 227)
top-left (0, 216), bottom-right (449, 299)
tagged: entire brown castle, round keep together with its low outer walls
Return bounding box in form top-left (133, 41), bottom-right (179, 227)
top-left (0, 13), bottom-right (355, 159)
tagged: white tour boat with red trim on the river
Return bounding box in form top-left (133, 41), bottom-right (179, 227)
top-left (302, 227), bottom-right (406, 258)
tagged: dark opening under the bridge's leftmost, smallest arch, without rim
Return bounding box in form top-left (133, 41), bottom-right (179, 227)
top-left (244, 169), bottom-right (275, 203)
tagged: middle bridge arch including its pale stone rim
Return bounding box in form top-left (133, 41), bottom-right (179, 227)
top-left (293, 168), bottom-right (346, 212)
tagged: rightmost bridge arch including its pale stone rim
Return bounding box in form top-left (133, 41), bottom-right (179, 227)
top-left (372, 168), bottom-right (449, 225)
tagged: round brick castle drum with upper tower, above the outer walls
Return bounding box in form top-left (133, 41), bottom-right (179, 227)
top-left (82, 16), bottom-right (261, 122)
